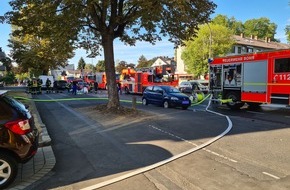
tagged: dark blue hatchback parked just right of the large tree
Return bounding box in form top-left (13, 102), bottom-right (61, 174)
top-left (142, 85), bottom-right (191, 109)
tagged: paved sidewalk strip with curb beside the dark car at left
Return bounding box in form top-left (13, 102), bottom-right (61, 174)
top-left (8, 96), bottom-right (56, 190)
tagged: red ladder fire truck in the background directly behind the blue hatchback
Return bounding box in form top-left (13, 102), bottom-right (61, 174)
top-left (120, 68), bottom-right (178, 94)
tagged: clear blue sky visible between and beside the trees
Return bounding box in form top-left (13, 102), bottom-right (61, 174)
top-left (0, 0), bottom-right (290, 65)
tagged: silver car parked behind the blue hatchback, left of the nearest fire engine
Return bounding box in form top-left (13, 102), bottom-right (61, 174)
top-left (178, 80), bottom-right (208, 93)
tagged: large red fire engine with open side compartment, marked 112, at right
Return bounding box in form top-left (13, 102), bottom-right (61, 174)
top-left (209, 49), bottom-right (290, 109)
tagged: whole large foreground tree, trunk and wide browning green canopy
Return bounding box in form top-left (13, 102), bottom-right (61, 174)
top-left (8, 0), bottom-right (216, 109)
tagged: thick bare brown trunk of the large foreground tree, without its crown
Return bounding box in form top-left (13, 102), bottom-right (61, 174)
top-left (102, 34), bottom-right (120, 109)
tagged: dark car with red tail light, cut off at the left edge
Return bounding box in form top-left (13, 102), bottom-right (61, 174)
top-left (0, 90), bottom-right (39, 189)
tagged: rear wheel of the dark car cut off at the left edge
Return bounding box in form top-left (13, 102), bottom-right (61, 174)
top-left (0, 152), bottom-right (18, 189)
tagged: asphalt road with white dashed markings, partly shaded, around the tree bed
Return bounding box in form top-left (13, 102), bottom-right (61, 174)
top-left (25, 93), bottom-right (290, 190)
